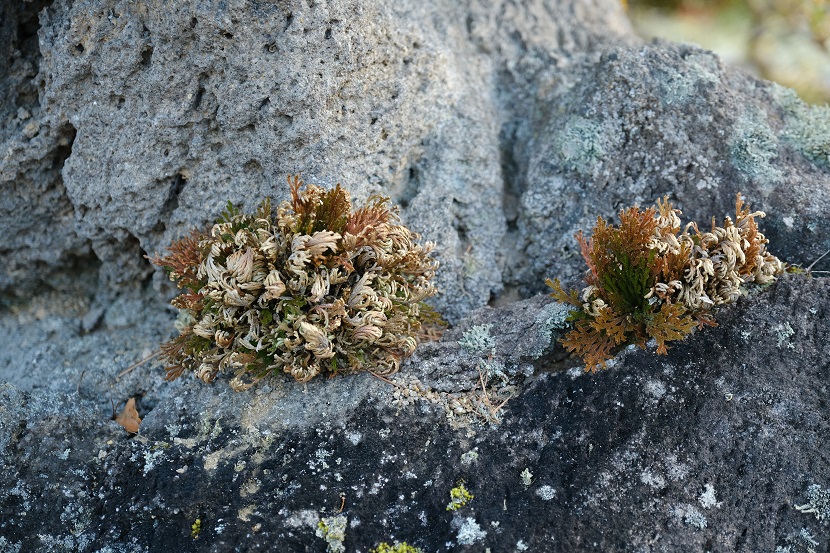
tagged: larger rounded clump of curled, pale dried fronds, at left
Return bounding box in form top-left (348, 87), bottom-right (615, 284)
top-left (152, 177), bottom-right (440, 389)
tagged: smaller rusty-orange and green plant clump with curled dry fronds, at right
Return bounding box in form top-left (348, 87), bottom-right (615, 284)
top-left (547, 194), bottom-right (784, 372)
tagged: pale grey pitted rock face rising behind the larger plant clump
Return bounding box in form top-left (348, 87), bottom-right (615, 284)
top-left (0, 0), bottom-right (628, 320)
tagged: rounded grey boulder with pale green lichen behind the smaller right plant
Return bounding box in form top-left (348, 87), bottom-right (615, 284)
top-left (507, 42), bottom-right (830, 294)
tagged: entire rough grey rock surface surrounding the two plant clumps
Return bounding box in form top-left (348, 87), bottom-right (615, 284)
top-left (0, 0), bottom-right (830, 553)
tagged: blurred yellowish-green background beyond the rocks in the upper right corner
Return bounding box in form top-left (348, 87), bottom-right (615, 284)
top-left (623, 0), bottom-right (830, 104)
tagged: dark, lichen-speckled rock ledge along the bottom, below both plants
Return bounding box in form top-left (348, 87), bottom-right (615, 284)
top-left (0, 277), bottom-right (830, 551)
